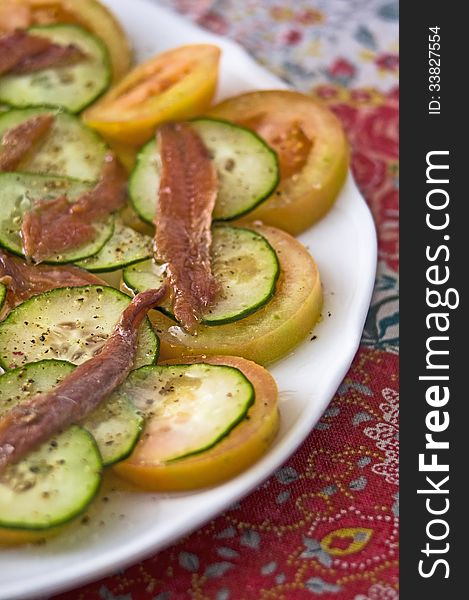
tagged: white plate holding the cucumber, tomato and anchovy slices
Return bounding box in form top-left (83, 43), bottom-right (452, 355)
top-left (0, 0), bottom-right (376, 600)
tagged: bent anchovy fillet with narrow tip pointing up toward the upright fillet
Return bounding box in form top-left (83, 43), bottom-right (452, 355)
top-left (21, 154), bottom-right (126, 263)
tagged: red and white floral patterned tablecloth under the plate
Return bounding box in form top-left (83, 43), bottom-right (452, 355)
top-left (56, 0), bottom-right (399, 600)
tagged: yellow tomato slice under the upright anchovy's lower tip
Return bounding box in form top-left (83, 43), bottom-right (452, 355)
top-left (149, 225), bottom-right (322, 365)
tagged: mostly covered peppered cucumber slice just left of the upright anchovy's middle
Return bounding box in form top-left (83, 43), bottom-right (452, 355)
top-left (75, 218), bottom-right (153, 273)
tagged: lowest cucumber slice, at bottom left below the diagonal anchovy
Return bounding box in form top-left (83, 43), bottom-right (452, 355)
top-left (0, 426), bottom-right (102, 530)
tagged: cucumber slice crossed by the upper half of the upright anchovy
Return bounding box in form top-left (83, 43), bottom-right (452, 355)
top-left (129, 119), bottom-right (279, 223)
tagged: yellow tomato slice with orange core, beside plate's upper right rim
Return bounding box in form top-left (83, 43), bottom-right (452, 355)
top-left (207, 90), bottom-right (349, 235)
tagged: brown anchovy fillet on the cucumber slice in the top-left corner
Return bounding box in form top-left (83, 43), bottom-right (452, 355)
top-left (0, 29), bottom-right (86, 75)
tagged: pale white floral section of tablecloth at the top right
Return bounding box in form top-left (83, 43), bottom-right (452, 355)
top-left (160, 0), bottom-right (399, 91)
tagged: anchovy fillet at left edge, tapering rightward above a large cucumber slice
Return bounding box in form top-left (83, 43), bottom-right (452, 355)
top-left (0, 250), bottom-right (104, 318)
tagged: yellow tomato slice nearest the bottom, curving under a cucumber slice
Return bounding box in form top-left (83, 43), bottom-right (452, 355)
top-left (114, 356), bottom-right (279, 491)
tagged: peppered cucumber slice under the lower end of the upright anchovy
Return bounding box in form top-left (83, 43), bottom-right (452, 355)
top-left (123, 226), bottom-right (280, 325)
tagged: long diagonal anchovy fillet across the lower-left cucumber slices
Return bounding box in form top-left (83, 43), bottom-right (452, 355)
top-left (0, 286), bottom-right (166, 471)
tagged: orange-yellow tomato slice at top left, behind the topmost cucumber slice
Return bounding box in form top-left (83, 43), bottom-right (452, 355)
top-left (0, 0), bottom-right (132, 82)
